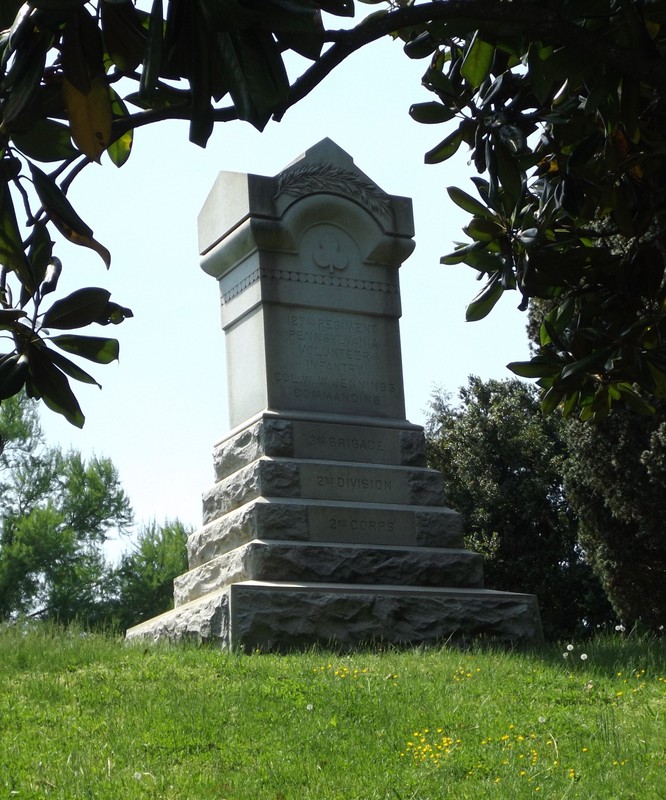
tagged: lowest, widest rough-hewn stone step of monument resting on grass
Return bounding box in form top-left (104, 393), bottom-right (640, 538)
top-left (127, 581), bottom-right (541, 652)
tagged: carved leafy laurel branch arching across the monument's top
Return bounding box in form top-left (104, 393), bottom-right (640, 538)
top-left (275, 164), bottom-right (391, 217)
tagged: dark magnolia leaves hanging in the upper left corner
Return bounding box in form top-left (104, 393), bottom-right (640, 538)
top-left (0, 0), bottom-right (354, 427)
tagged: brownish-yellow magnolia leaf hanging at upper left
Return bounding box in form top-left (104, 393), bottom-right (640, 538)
top-left (62, 75), bottom-right (113, 161)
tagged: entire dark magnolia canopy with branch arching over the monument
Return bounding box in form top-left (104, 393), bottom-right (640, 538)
top-left (0, 0), bottom-right (666, 425)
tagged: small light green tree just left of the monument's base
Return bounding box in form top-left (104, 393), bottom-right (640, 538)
top-left (116, 520), bottom-right (190, 628)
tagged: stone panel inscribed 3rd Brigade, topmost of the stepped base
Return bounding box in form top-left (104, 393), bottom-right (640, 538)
top-left (292, 421), bottom-right (400, 464)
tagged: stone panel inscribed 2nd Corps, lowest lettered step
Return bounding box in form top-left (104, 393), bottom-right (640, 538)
top-left (308, 506), bottom-right (416, 546)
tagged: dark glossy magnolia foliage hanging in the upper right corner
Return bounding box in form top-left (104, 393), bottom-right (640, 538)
top-left (401, 0), bottom-right (666, 421)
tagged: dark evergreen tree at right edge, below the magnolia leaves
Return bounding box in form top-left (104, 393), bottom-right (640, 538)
top-left (564, 404), bottom-right (666, 631)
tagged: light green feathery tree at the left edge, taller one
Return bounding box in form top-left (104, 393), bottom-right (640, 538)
top-left (0, 394), bottom-right (132, 625)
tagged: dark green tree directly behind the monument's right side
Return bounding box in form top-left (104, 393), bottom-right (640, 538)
top-left (426, 377), bottom-right (613, 637)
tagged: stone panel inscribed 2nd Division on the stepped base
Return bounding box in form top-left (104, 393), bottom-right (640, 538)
top-left (300, 464), bottom-right (409, 504)
